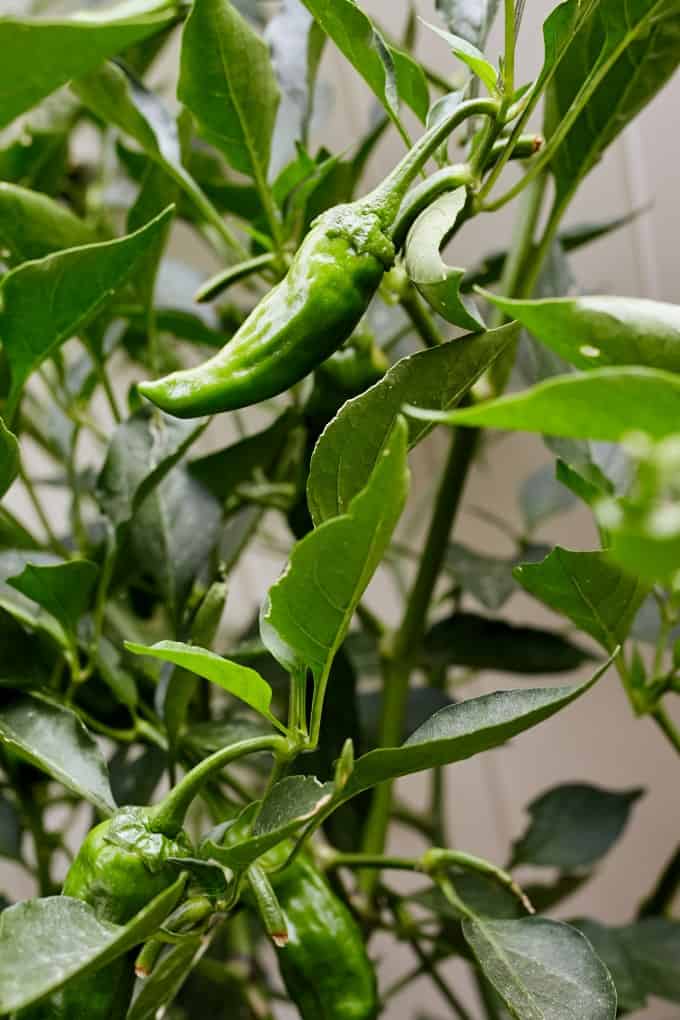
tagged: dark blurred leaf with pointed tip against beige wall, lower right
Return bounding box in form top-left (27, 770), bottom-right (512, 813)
top-left (511, 783), bottom-right (644, 872)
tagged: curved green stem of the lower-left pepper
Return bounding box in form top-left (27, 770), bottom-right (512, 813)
top-left (149, 734), bottom-right (289, 838)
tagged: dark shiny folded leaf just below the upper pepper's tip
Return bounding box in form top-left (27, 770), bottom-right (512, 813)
top-left (97, 412), bottom-right (206, 527)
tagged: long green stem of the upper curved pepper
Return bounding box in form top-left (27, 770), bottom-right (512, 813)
top-left (360, 99), bottom-right (501, 226)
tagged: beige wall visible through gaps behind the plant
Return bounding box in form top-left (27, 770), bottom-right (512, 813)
top-left (0, 0), bottom-right (680, 1020)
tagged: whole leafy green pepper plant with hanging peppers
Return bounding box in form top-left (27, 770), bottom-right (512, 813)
top-left (0, 0), bottom-right (680, 1020)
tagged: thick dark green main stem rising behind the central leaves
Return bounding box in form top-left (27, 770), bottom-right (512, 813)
top-left (361, 428), bottom-right (479, 895)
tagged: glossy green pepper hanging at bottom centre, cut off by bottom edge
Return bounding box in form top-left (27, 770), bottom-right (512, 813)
top-left (271, 857), bottom-right (378, 1020)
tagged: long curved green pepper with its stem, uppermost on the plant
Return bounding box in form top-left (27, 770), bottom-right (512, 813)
top-left (139, 99), bottom-right (499, 418)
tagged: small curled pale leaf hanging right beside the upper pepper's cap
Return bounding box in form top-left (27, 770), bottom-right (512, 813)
top-left (404, 188), bottom-right (487, 333)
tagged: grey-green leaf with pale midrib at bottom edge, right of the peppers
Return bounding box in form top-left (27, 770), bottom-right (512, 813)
top-left (463, 917), bottom-right (617, 1020)
